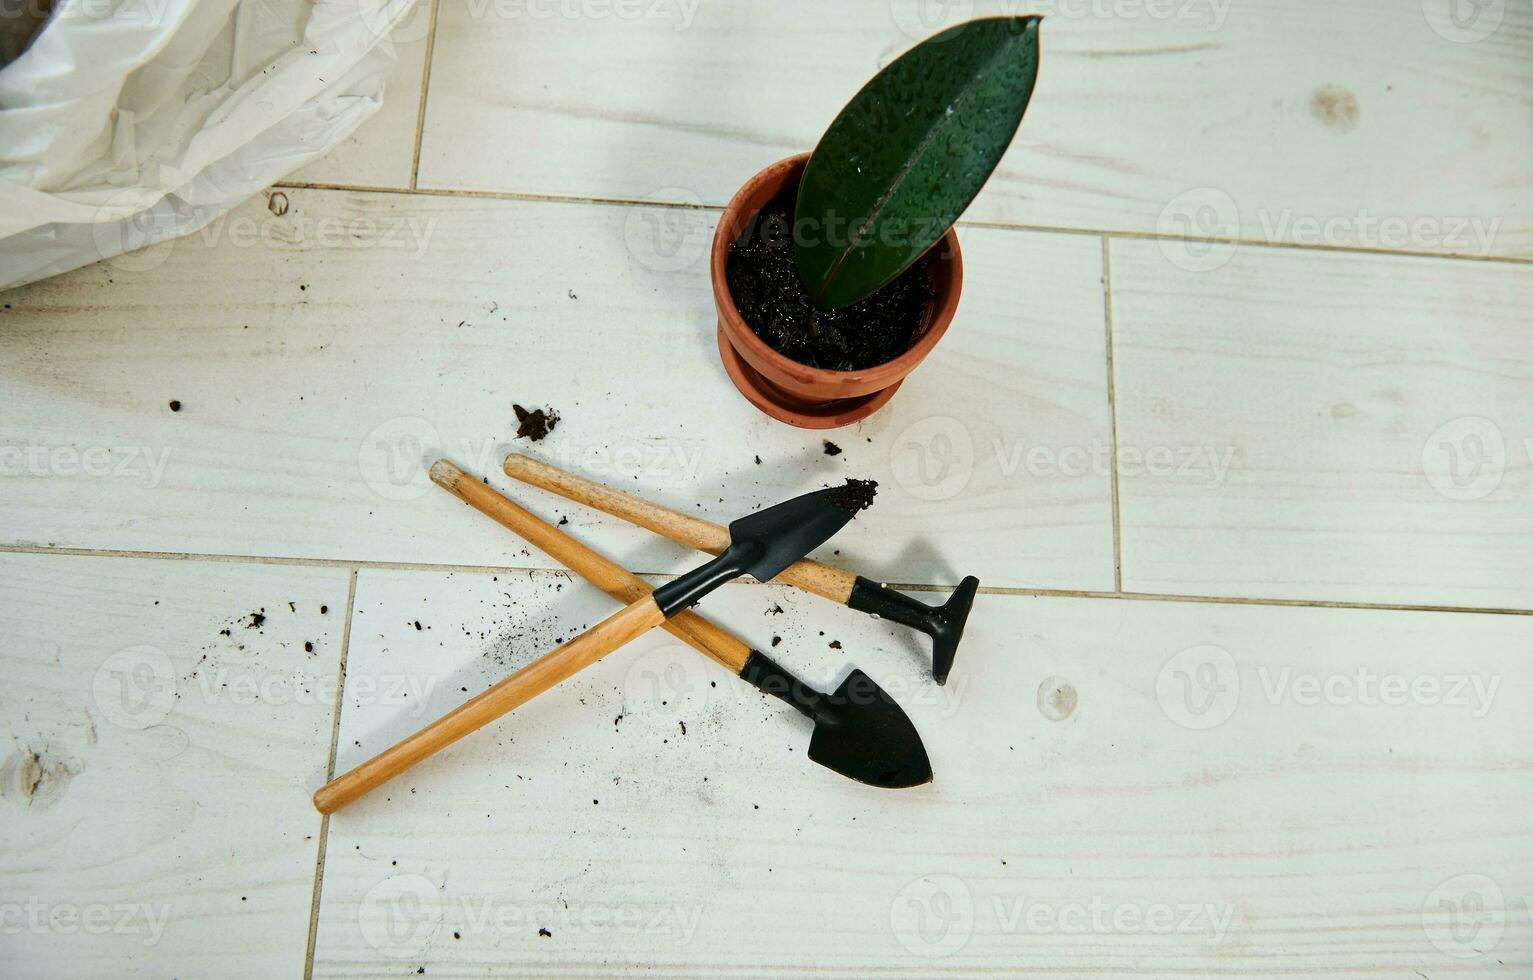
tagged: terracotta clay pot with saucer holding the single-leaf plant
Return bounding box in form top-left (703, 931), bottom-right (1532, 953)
top-left (708, 153), bottom-right (963, 429)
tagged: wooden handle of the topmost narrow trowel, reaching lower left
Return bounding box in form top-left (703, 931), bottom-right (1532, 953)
top-left (314, 597), bottom-right (665, 813)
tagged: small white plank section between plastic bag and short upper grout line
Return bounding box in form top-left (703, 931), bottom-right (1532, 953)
top-left (284, 7), bottom-right (432, 189)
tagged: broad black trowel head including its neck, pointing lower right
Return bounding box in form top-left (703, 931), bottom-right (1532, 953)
top-left (740, 650), bottom-right (932, 790)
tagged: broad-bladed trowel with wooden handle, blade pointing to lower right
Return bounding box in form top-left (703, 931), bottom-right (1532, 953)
top-left (431, 460), bottom-right (932, 790)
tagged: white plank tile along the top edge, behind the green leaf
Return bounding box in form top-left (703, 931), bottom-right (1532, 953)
top-left (420, 0), bottom-right (1533, 260)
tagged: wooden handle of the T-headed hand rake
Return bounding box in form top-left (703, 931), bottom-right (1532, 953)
top-left (506, 452), bottom-right (857, 606)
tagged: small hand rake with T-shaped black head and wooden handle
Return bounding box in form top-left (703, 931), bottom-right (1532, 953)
top-left (504, 452), bottom-right (980, 684)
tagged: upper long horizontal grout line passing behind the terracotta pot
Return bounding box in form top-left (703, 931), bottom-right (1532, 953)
top-left (273, 180), bottom-right (1533, 265)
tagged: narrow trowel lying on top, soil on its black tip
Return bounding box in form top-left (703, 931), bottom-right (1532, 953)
top-left (314, 466), bottom-right (872, 813)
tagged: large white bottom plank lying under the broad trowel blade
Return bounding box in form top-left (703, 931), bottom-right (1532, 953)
top-left (314, 571), bottom-right (1533, 977)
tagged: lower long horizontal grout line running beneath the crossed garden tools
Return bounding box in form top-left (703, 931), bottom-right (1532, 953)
top-left (0, 544), bottom-right (1533, 617)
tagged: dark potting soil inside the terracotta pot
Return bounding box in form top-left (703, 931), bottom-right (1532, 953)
top-left (724, 187), bottom-right (932, 371)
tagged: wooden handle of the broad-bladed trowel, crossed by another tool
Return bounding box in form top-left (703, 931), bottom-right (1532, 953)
top-left (431, 460), bottom-right (751, 673)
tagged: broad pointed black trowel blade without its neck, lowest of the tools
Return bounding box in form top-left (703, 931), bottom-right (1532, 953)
top-left (809, 670), bottom-right (932, 790)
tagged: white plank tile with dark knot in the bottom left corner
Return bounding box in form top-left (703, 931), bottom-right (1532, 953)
top-left (0, 554), bottom-right (348, 978)
